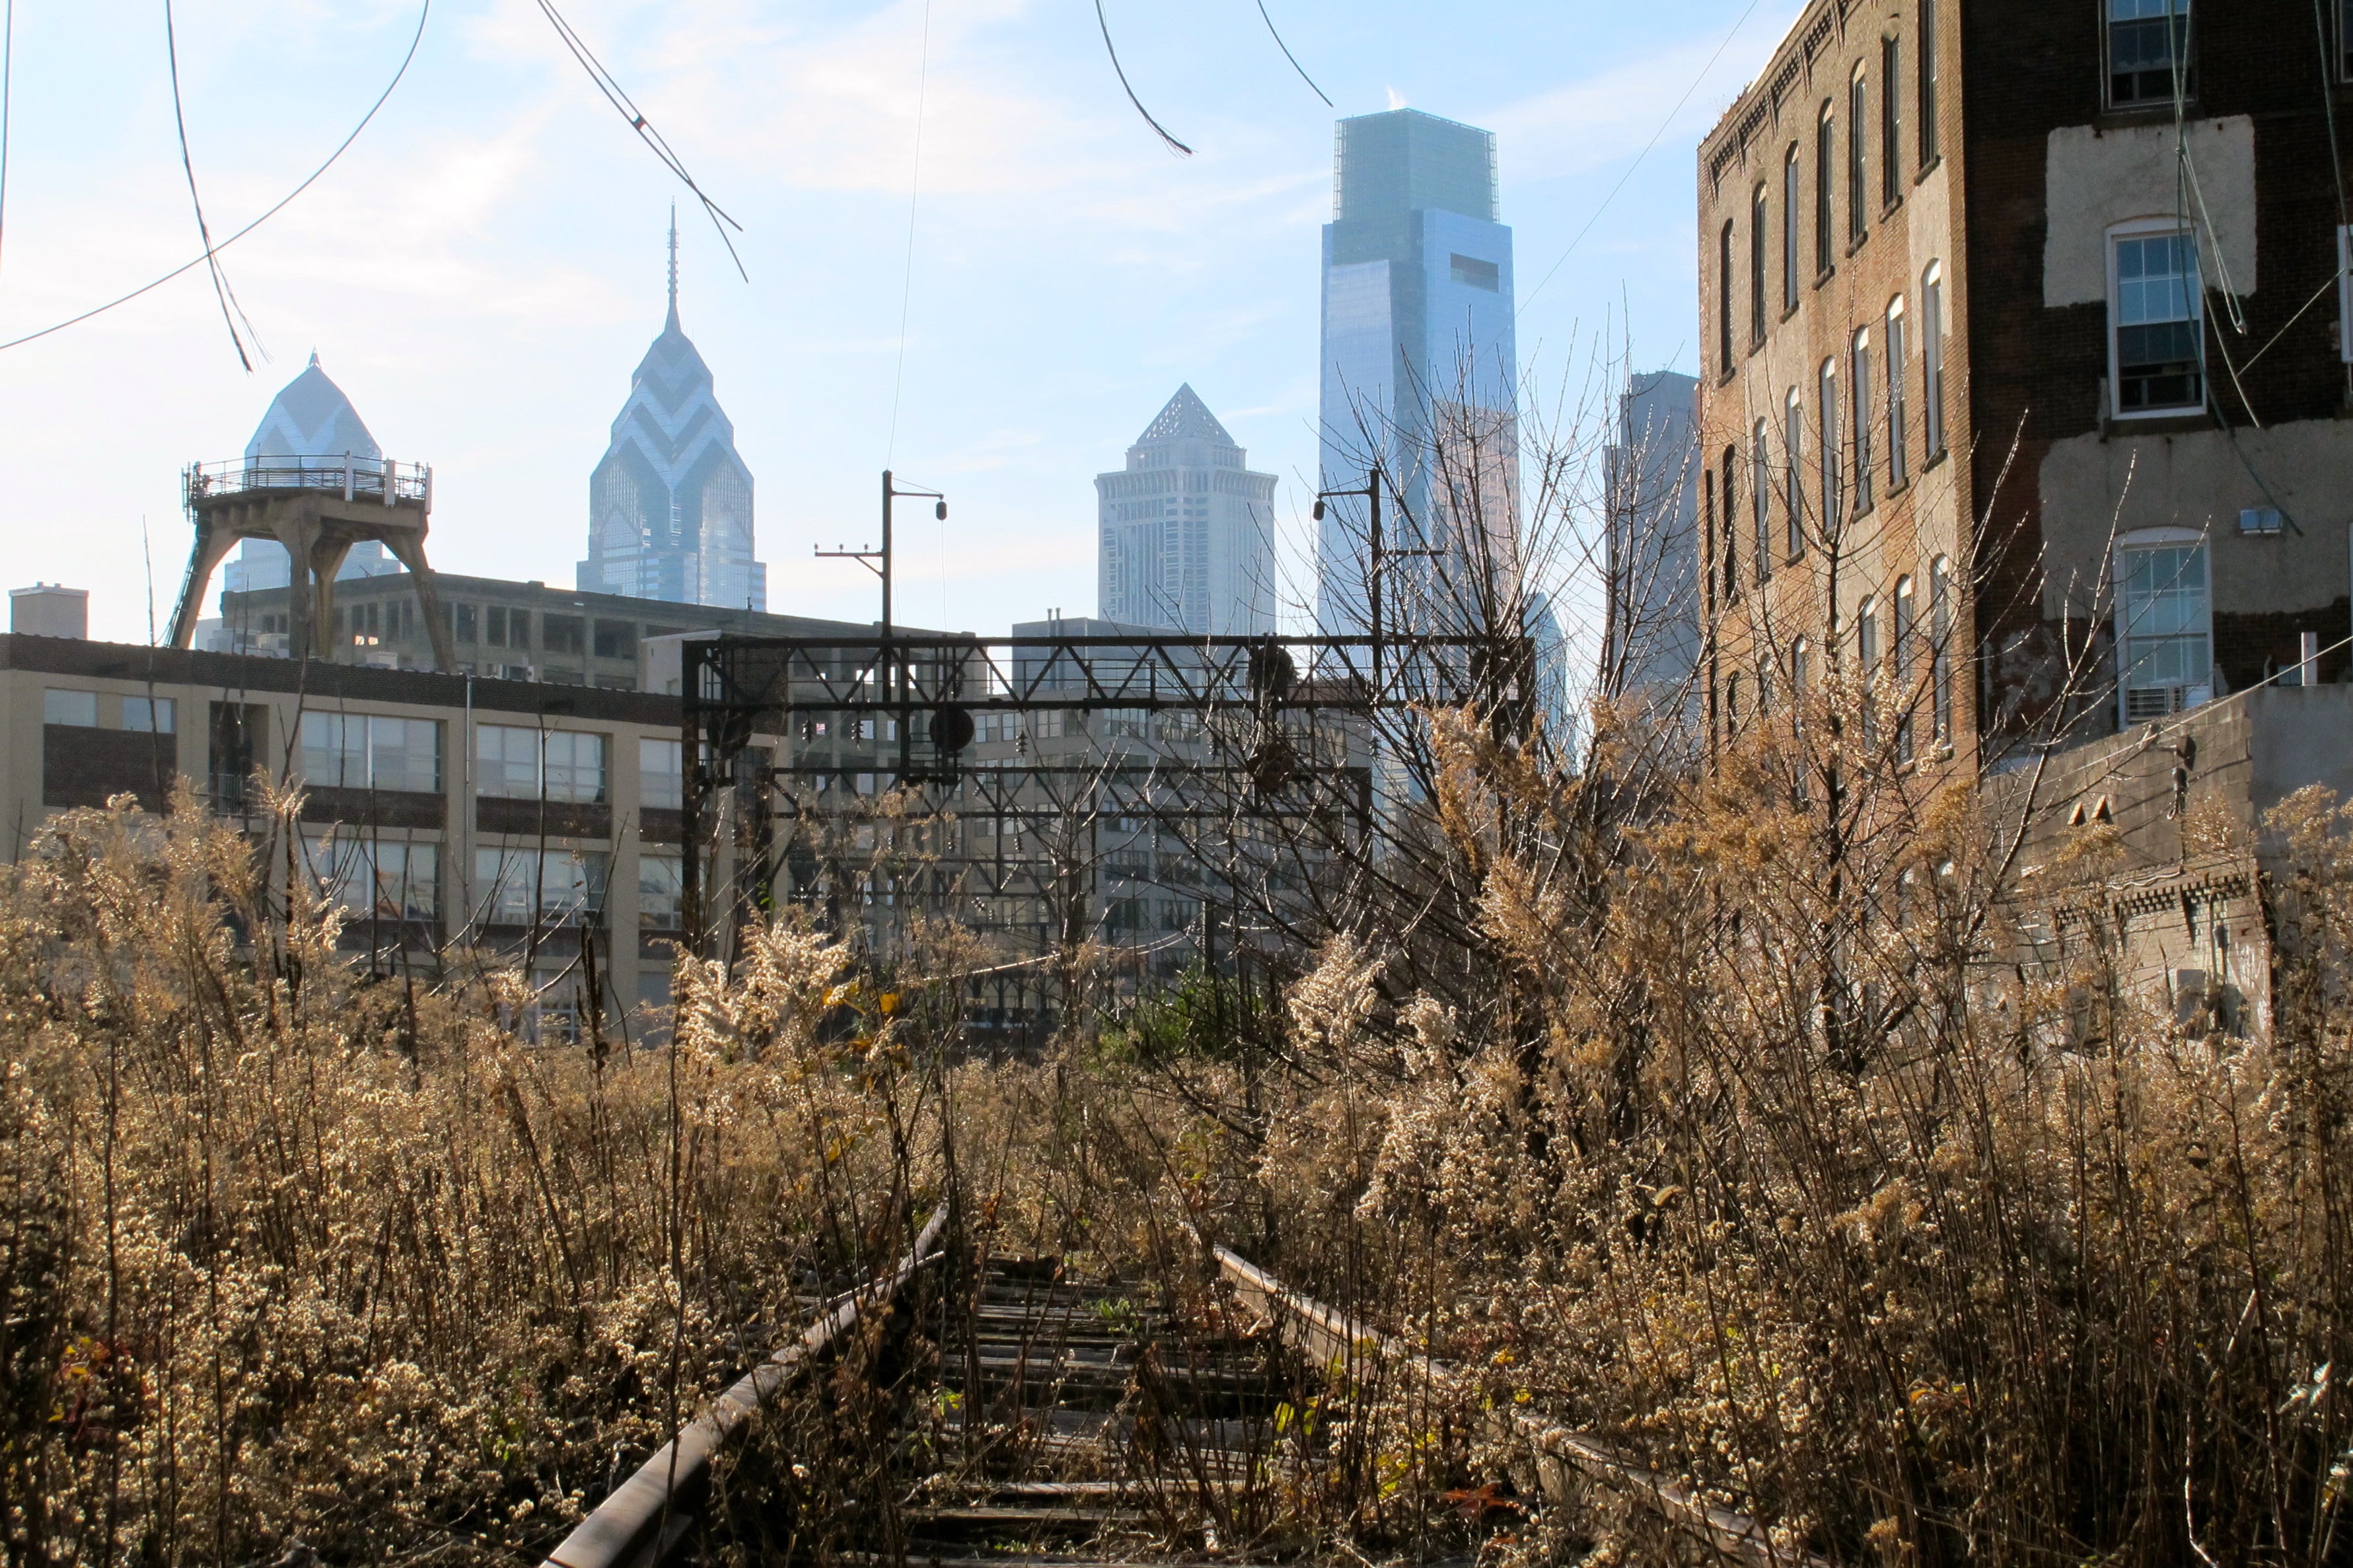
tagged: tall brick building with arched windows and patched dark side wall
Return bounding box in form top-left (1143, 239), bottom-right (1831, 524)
top-left (1699, 0), bottom-right (2353, 767)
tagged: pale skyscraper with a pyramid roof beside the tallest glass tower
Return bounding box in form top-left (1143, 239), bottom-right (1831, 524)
top-left (1094, 386), bottom-right (1276, 635)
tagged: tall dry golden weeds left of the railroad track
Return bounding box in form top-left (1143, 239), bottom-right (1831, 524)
top-left (0, 798), bottom-right (939, 1563)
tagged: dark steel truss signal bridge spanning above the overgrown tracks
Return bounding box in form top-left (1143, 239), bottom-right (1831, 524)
top-left (680, 631), bottom-right (1534, 954)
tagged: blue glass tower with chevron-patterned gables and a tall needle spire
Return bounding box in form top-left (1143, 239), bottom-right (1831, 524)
top-left (577, 207), bottom-right (767, 610)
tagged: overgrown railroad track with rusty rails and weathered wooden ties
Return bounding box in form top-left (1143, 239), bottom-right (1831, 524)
top-left (546, 1213), bottom-right (1830, 1568)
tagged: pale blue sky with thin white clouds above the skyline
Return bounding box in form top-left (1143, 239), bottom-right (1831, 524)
top-left (0, 0), bottom-right (1797, 643)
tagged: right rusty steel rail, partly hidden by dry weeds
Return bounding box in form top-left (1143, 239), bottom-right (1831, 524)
top-left (1212, 1248), bottom-right (1833, 1568)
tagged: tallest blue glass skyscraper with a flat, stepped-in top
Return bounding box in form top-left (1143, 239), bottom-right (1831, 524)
top-left (1315, 108), bottom-right (1520, 633)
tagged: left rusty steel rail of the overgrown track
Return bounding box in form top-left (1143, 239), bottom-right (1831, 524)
top-left (541, 1203), bottom-right (948, 1568)
